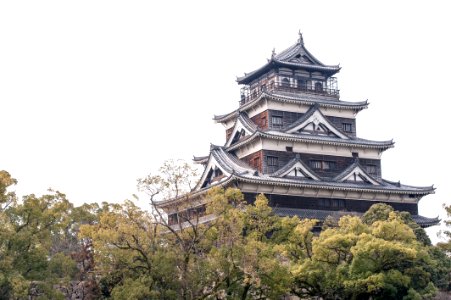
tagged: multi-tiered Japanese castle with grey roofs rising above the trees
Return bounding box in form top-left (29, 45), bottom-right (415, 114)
top-left (158, 34), bottom-right (439, 227)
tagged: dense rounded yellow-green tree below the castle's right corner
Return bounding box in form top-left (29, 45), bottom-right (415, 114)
top-left (294, 212), bottom-right (435, 299)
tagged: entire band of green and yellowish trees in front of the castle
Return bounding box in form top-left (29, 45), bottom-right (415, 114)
top-left (0, 168), bottom-right (451, 299)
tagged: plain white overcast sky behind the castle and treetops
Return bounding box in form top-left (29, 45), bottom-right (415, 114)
top-left (0, 0), bottom-right (451, 244)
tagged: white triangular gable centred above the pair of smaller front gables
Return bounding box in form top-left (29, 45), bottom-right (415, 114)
top-left (286, 109), bottom-right (349, 140)
